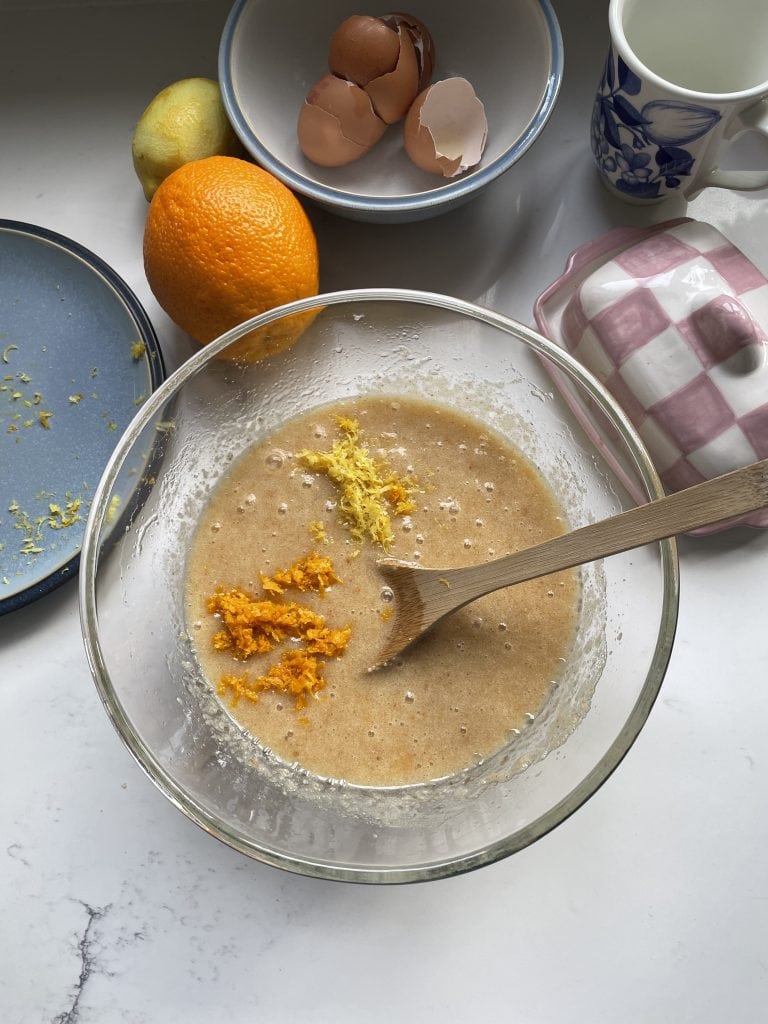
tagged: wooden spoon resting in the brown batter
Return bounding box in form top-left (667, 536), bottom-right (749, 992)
top-left (372, 459), bottom-right (768, 669)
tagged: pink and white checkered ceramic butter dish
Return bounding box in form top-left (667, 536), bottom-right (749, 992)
top-left (536, 220), bottom-right (768, 526)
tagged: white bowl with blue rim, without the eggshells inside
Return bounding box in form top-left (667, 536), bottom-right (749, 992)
top-left (219, 0), bottom-right (563, 222)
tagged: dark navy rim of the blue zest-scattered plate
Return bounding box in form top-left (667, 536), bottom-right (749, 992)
top-left (0, 218), bottom-right (166, 615)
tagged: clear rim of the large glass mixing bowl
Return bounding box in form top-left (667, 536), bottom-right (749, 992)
top-left (79, 288), bottom-right (679, 883)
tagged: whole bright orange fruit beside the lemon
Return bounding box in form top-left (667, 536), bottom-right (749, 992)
top-left (144, 151), bottom-right (318, 360)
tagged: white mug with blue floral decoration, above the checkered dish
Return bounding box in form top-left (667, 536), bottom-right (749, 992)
top-left (592, 0), bottom-right (768, 203)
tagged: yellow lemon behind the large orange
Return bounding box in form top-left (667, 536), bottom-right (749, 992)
top-left (132, 78), bottom-right (243, 202)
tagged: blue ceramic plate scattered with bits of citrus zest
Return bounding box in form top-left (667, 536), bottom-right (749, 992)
top-left (0, 220), bottom-right (165, 614)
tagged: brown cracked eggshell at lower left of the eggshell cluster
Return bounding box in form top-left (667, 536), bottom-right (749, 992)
top-left (297, 75), bottom-right (386, 167)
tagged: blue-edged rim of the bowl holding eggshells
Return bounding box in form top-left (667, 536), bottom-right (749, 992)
top-left (218, 0), bottom-right (564, 213)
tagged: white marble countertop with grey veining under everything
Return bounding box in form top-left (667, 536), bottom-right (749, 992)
top-left (0, 0), bottom-right (768, 1024)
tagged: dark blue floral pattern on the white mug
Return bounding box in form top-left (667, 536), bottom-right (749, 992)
top-left (591, 46), bottom-right (721, 200)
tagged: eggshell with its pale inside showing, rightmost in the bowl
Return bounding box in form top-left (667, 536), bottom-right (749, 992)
top-left (403, 78), bottom-right (488, 178)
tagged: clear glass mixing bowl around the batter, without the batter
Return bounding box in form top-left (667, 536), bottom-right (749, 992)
top-left (80, 290), bottom-right (678, 883)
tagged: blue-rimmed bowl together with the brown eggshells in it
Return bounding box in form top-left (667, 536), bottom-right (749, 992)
top-left (219, 0), bottom-right (563, 222)
